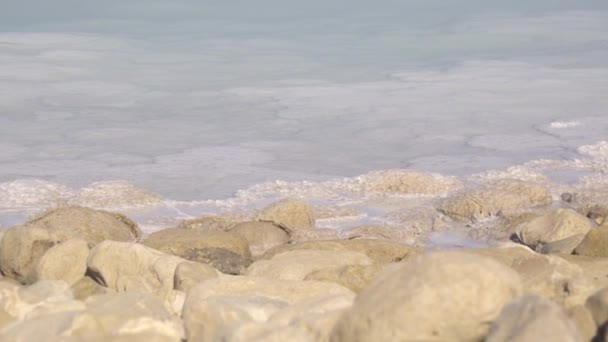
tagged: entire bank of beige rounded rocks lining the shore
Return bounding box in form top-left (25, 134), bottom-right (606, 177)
top-left (0, 182), bottom-right (608, 342)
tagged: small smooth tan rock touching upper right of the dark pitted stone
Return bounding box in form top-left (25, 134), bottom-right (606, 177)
top-left (230, 221), bottom-right (289, 256)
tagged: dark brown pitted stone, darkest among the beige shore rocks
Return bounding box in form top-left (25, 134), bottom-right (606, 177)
top-left (183, 247), bottom-right (253, 275)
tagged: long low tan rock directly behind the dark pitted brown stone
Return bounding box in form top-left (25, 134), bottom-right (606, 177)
top-left (142, 228), bottom-right (251, 258)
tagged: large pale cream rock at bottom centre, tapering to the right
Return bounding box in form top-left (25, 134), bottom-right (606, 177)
top-left (182, 276), bottom-right (354, 341)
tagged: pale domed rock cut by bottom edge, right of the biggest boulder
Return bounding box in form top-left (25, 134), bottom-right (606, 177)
top-left (485, 295), bottom-right (582, 342)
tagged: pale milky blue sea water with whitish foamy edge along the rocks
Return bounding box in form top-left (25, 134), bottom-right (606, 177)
top-left (0, 0), bottom-right (608, 242)
